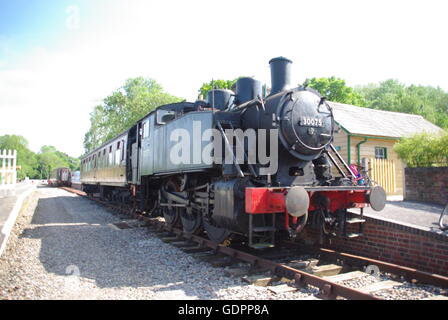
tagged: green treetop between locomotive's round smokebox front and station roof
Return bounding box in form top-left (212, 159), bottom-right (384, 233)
top-left (303, 77), bottom-right (365, 107)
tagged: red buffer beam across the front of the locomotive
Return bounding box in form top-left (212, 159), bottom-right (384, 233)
top-left (246, 188), bottom-right (369, 214)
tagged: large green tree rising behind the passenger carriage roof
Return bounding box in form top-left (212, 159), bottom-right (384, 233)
top-left (84, 77), bottom-right (181, 152)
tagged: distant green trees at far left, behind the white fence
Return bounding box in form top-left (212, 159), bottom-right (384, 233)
top-left (0, 135), bottom-right (80, 179)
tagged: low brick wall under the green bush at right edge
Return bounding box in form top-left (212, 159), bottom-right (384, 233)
top-left (404, 167), bottom-right (448, 205)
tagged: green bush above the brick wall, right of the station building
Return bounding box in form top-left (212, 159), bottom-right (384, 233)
top-left (394, 133), bottom-right (448, 167)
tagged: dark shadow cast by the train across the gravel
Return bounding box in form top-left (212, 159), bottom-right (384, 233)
top-left (21, 192), bottom-right (234, 299)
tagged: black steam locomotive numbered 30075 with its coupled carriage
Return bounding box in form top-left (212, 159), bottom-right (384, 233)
top-left (81, 57), bottom-right (386, 248)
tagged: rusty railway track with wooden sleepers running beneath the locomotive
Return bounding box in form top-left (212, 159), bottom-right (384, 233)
top-left (62, 187), bottom-right (448, 300)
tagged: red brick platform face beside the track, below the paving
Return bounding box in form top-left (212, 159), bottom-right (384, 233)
top-left (302, 216), bottom-right (448, 276)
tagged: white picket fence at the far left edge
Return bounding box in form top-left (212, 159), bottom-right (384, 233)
top-left (0, 150), bottom-right (17, 196)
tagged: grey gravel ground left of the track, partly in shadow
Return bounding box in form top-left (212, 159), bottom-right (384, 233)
top-left (0, 187), bottom-right (444, 300)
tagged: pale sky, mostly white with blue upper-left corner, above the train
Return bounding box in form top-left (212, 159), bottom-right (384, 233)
top-left (0, 0), bottom-right (448, 157)
